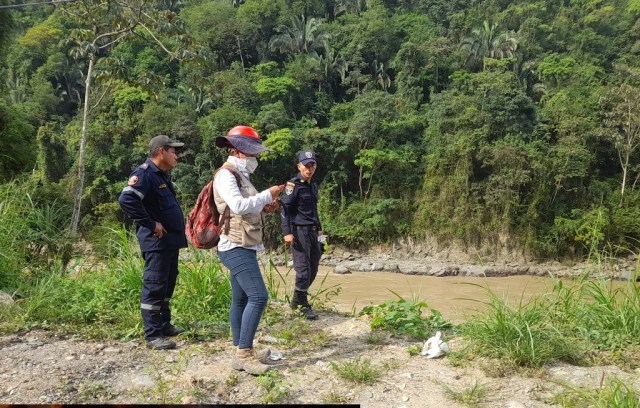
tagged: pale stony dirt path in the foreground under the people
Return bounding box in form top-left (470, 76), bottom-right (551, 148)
top-left (0, 313), bottom-right (640, 408)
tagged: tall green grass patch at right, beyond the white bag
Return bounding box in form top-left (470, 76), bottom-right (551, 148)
top-left (461, 275), bottom-right (640, 367)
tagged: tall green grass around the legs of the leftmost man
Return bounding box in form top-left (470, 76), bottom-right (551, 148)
top-left (3, 229), bottom-right (231, 339)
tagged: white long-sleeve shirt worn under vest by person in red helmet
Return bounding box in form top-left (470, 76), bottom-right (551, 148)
top-left (213, 156), bottom-right (273, 252)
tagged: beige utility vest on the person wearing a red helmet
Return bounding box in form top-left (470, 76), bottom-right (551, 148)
top-left (213, 162), bottom-right (264, 247)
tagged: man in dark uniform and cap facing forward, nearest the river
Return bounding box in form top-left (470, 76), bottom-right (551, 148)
top-left (280, 151), bottom-right (322, 320)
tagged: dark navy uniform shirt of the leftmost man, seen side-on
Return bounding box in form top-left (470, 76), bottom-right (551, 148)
top-left (118, 159), bottom-right (187, 252)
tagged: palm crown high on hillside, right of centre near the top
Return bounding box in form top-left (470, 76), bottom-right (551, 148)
top-left (460, 20), bottom-right (518, 71)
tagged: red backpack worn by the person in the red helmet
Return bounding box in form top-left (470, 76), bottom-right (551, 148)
top-left (186, 166), bottom-right (240, 249)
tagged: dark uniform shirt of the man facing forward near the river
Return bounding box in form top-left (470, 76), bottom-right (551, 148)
top-left (280, 173), bottom-right (322, 235)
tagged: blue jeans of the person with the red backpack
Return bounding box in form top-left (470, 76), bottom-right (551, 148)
top-left (218, 247), bottom-right (269, 349)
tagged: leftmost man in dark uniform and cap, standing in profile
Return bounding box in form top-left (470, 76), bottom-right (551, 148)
top-left (118, 135), bottom-right (187, 350)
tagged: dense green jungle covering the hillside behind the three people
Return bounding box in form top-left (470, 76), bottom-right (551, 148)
top-left (0, 0), bottom-right (640, 270)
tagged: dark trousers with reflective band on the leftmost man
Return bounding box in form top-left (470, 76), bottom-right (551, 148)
top-left (140, 249), bottom-right (180, 340)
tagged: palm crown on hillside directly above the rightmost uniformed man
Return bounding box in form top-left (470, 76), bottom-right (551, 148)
top-left (269, 16), bottom-right (329, 58)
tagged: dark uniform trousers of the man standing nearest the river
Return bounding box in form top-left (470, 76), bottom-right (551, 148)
top-left (291, 226), bottom-right (322, 292)
